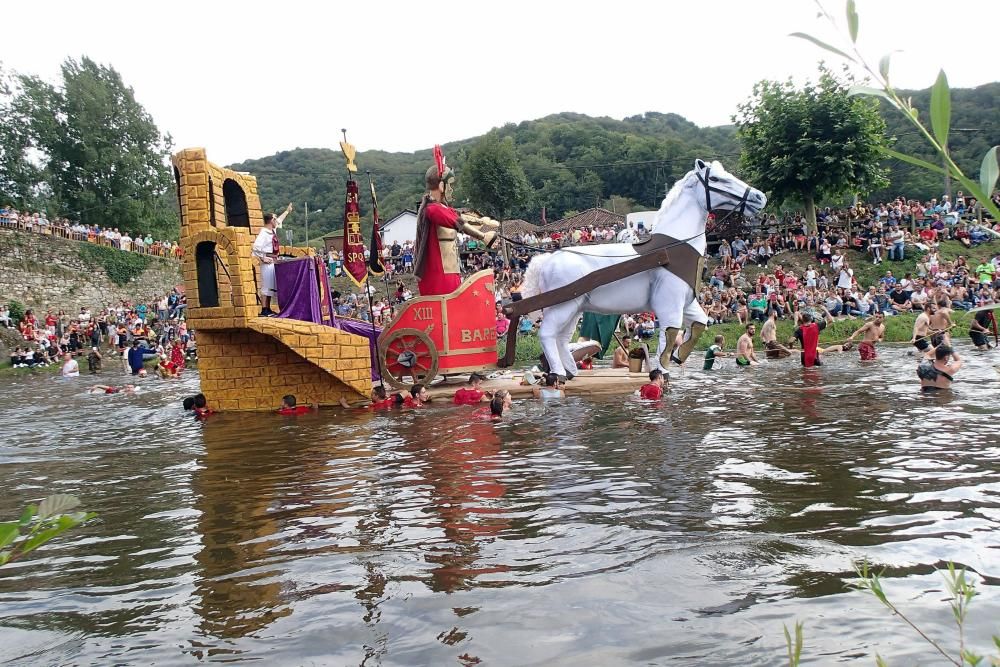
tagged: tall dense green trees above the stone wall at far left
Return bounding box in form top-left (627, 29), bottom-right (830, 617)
top-left (0, 57), bottom-right (177, 237)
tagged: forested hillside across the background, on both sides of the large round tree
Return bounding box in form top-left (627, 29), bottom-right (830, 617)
top-left (233, 83), bottom-right (1000, 240)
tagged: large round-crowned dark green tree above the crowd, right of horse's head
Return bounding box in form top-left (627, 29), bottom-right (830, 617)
top-left (733, 64), bottom-right (888, 229)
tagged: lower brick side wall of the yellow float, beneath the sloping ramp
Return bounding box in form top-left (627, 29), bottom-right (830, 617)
top-left (198, 331), bottom-right (370, 410)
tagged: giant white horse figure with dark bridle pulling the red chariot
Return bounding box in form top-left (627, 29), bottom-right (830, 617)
top-left (521, 160), bottom-right (767, 377)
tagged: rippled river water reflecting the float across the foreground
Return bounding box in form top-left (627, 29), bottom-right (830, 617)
top-left (0, 346), bottom-right (1000, 665)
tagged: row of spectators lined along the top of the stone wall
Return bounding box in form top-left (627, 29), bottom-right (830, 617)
top-left (0, 206), bottom-right (184, 258)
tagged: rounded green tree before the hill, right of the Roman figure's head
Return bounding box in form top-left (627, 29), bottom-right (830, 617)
top-left (461, 131), bottom-right (531, 220)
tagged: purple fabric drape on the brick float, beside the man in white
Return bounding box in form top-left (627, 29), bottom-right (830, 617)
top-left (274, 257), bottom-right (382, 380)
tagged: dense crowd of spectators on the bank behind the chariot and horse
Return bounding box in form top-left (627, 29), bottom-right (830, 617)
top-left (288, 191), bottom-right (1000, 338)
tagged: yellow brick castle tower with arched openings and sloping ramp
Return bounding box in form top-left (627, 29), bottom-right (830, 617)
top-left (172, 148), bottom-right (371, 410)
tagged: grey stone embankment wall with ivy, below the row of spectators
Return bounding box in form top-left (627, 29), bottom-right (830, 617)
top-left (0, 229), bottom-right (181, 313)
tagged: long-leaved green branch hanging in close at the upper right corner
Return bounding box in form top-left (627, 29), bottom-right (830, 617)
top-left (791, 0), bottom-right (1000, 221)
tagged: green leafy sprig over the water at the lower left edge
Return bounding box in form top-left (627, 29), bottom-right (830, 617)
top-left (0, 493), bottom-right (97, 566)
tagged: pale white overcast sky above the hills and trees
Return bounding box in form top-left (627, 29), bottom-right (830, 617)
top-left (0, 0), bottom-right (1000, 164)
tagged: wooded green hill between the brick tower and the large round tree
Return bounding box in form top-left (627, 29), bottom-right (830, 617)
top-left (232, 113), bottom-right (738, 240)
